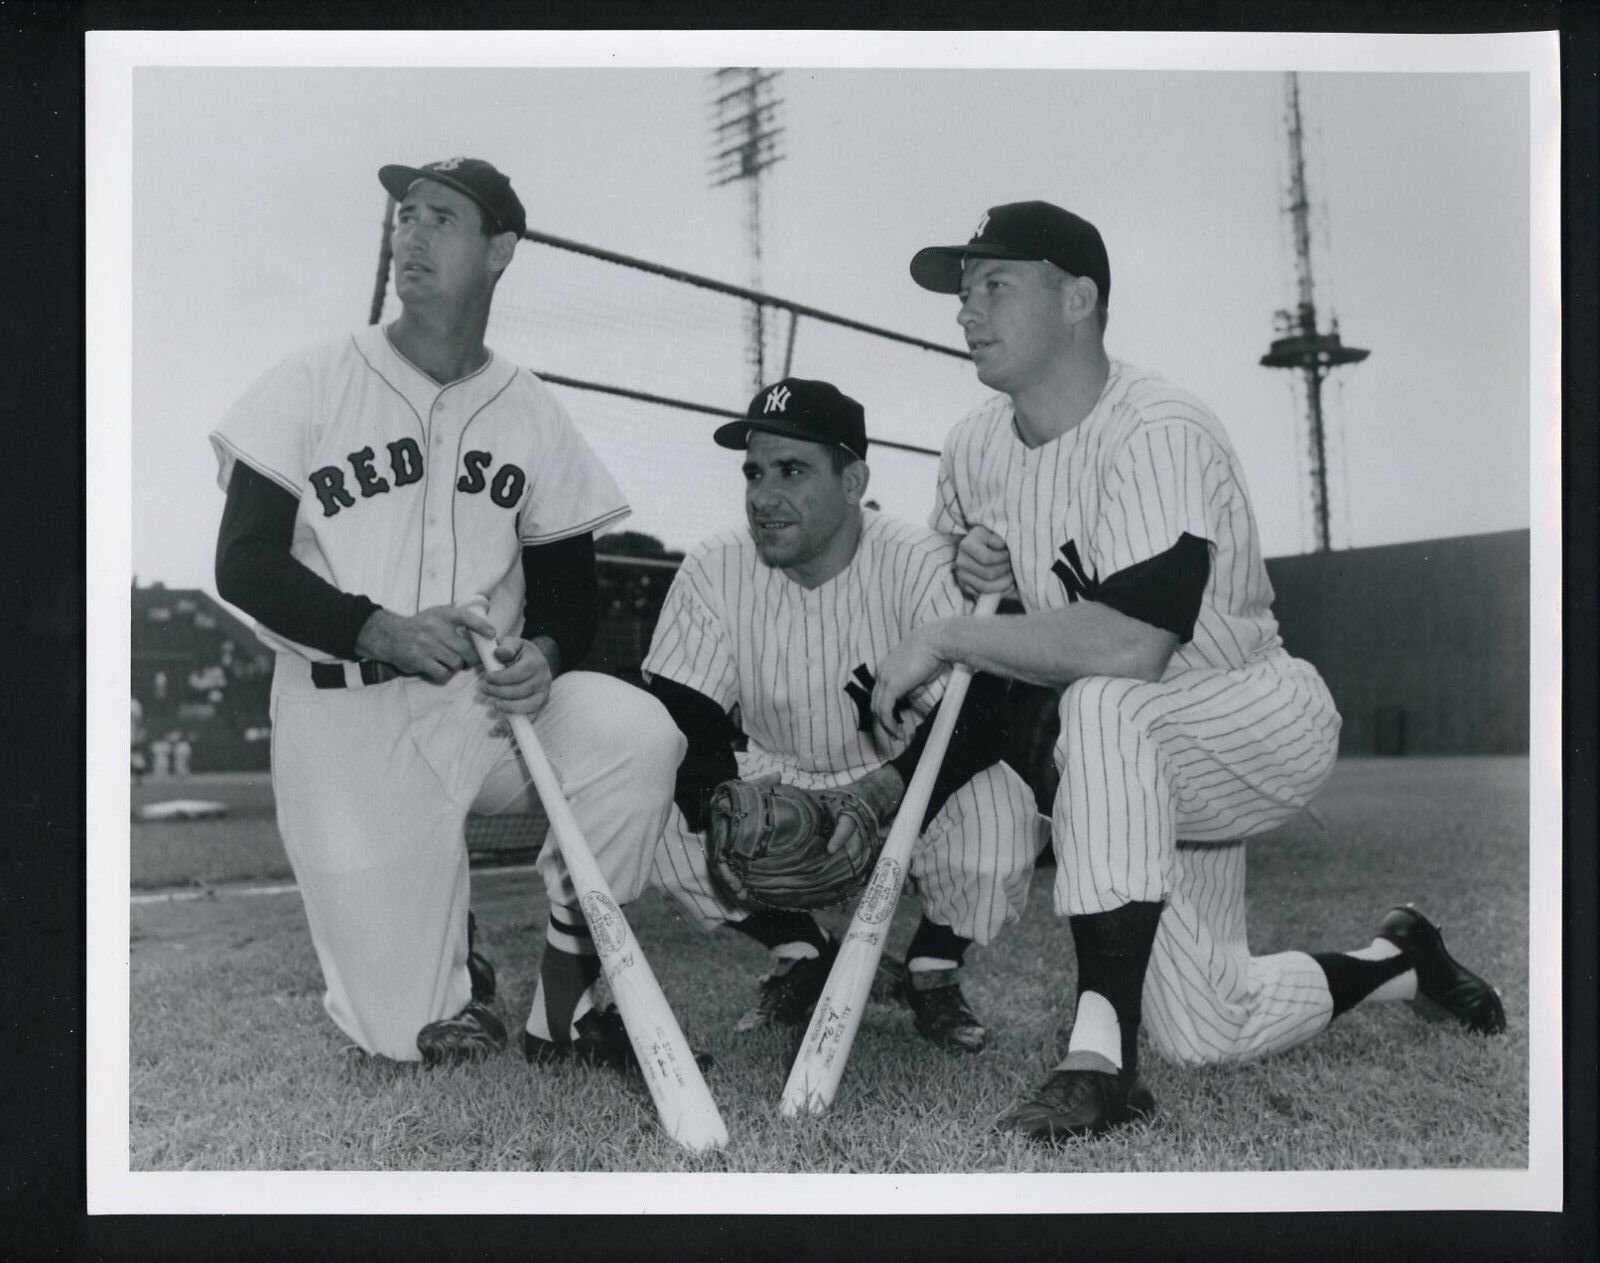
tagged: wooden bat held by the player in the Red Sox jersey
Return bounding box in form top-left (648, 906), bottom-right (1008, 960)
top-left (464, 597), bottom-right (728, 1153)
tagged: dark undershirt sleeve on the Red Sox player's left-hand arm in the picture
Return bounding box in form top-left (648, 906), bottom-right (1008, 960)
top-left (216, 461), bottom-right (379, 660)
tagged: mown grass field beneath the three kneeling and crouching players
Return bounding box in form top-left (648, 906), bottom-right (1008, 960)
top-left (130, 759), bottom-right (1528, 1173)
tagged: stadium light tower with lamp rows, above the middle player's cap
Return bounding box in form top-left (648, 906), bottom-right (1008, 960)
top-left (710, 66), bottom-right (784, 391)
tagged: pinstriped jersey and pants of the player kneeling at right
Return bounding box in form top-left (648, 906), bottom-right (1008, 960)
top-left (933, 360), bottom-right (1339, 1063)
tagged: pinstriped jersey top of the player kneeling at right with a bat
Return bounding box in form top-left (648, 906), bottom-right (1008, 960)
top-left (931, 360), bottom-right (1282, 677)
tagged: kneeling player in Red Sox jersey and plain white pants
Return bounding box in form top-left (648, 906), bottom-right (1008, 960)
top-left (211, 158), bottom-right (683, 1068)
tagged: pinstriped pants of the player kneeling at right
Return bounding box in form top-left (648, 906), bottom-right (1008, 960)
top-left (1051, 655), bottom-right (1339, 1065)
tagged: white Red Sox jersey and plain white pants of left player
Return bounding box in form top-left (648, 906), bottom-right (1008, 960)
top-left (211, 328), bottom-right (685, 1061)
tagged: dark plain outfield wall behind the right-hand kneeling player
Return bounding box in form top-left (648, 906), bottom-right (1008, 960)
top-left (1267, 530), bottom-right (1530, 754)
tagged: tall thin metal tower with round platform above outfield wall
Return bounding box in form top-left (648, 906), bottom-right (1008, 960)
top-left (1261, 70), bottom-right (1371, 552)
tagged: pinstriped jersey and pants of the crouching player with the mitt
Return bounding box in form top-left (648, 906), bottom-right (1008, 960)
top-left (643, 511), bottom-right (1040, 943)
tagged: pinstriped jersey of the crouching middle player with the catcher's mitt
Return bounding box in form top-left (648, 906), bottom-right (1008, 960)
top-left (643, 511), bottom-right (963, 786)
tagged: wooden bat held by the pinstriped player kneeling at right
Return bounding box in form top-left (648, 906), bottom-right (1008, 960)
top-left (782, 592), bottom-right (1000, 1117)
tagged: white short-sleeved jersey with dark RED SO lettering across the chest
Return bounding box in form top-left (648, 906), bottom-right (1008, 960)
top-left (211, 325), bottom-right (629, 661)
